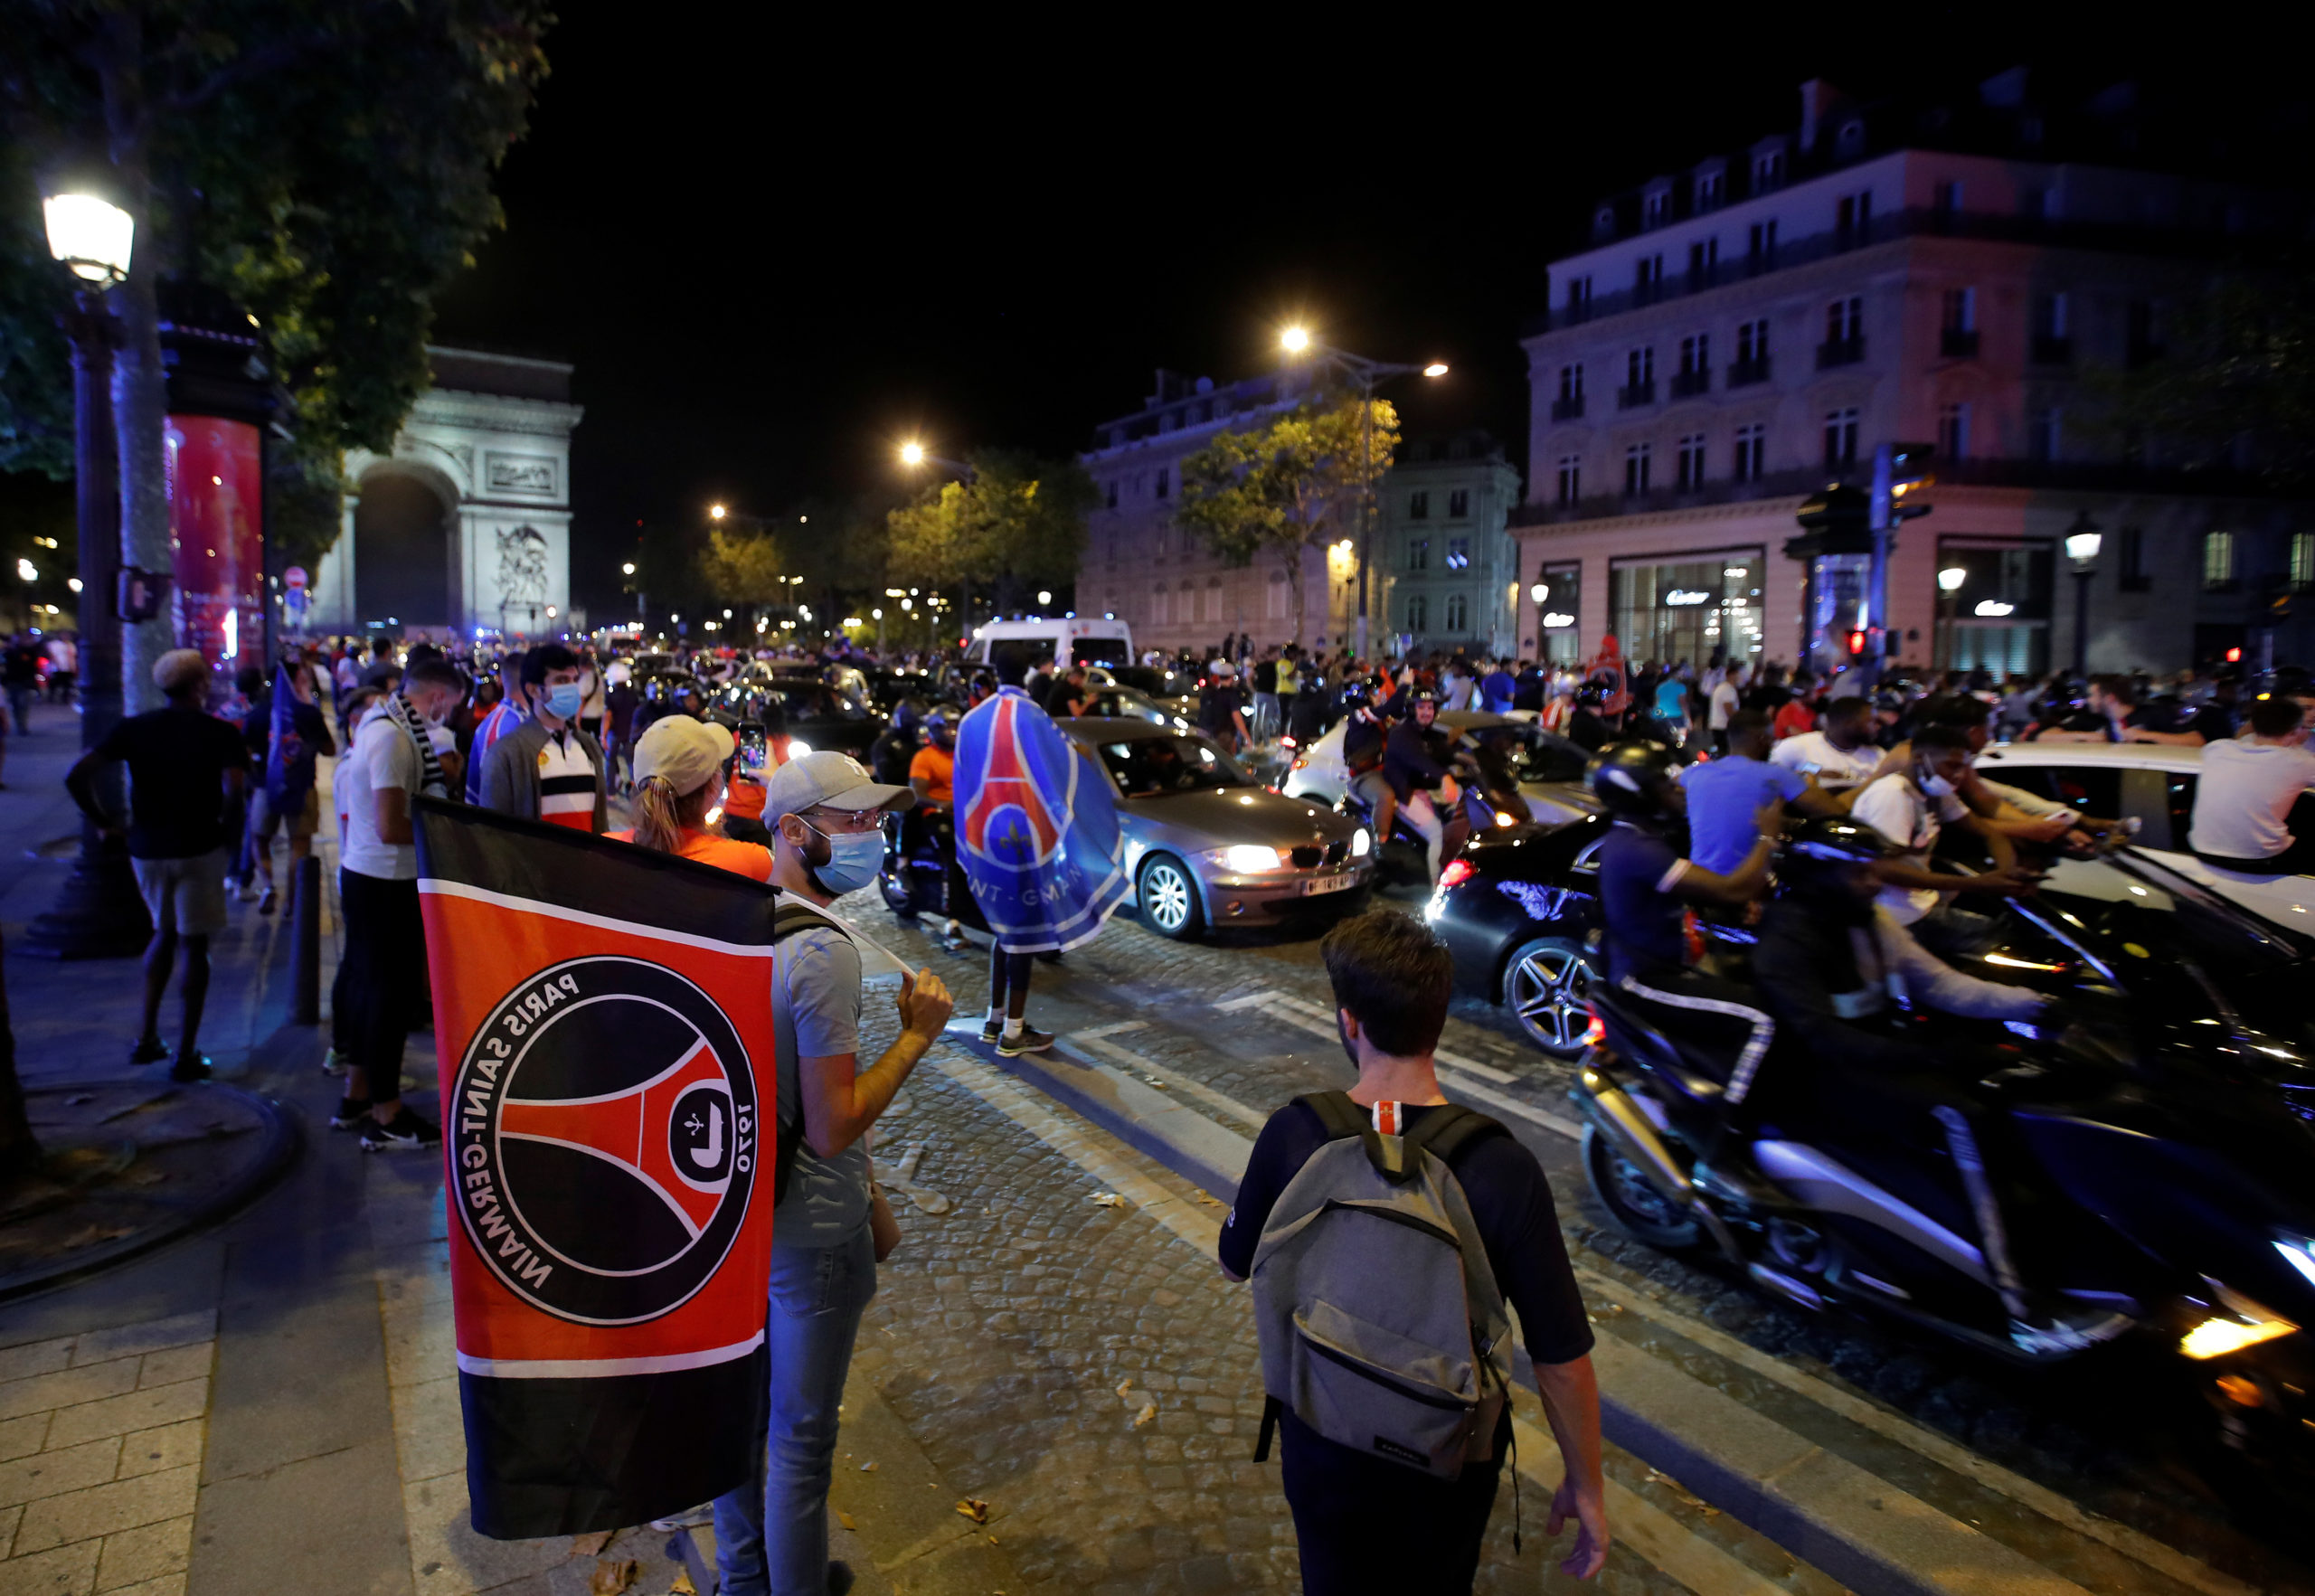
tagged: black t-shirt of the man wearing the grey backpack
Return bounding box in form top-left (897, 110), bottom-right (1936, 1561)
top-left (1218, 1100), bottom-right (1592, 1365)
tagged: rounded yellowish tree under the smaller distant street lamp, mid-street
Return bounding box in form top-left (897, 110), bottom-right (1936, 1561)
top-left (886, 449), bottom-right (1100, 621)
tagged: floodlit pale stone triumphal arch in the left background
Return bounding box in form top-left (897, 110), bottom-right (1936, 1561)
top-left (307, 347), bottom-right (583, 639)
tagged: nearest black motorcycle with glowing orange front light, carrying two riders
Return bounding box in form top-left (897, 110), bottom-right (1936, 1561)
top-left (1572, 862), bottom-right (2315, 1482)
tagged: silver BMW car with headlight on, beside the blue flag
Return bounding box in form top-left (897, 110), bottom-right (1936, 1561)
top-left (1055, 716), bottom-right (1375, 938)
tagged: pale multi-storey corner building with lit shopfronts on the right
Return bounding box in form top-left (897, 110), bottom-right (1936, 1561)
top-left (1514, 71), bottom-right (2315, 669)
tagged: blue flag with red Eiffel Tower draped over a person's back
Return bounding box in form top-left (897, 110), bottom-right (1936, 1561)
top-left (956, 688), bottom-right (1125, 952)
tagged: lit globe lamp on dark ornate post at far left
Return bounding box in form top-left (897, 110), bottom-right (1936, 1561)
top-left (18, 187), bottom-right (153, 959)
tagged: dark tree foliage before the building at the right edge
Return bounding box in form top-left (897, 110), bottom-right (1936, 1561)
top-left (2086, 260), bottom-right (2315, 484)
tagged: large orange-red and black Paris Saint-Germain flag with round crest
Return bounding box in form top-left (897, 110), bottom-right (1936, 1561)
top-left (417, 799), bottom-right (778, 1541)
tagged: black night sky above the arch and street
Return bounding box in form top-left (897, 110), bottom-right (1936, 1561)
top-left (420, 33), bottom-right (2204, 607)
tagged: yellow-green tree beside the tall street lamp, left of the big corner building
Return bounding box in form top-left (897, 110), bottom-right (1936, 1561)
top-left (1174, 399), bottom-right (1398, 644)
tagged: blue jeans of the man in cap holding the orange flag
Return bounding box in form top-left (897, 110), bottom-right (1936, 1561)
top-left (715, 1225), bottom-right (875, 1596)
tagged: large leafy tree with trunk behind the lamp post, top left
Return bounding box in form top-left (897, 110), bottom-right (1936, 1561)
top-left (0, 0), bottom-right (553, 702)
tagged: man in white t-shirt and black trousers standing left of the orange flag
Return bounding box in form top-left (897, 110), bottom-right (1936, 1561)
top-left (329, 658), bottom-right (466, 1151)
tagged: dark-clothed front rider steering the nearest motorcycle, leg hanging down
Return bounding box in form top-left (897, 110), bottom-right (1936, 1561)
top-left (1753, 816), bottom-right (2128, 1355)
